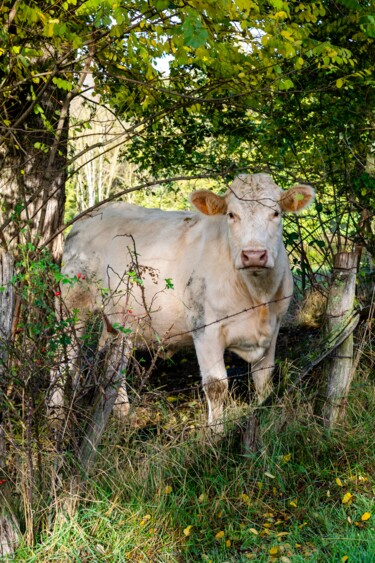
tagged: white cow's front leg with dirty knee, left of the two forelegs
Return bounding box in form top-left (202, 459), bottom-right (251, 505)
top-left (195, 339), bottom-right (228, 432)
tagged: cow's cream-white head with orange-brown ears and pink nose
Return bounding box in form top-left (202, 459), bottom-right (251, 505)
top-left (191, 174), bottom-right (314, 273)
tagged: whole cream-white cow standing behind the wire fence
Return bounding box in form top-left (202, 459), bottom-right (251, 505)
top-left (56, 174), bottom-right (314, 424)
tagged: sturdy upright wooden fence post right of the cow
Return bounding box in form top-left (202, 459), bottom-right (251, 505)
top-left (317, 252), bottom-right (358, 428)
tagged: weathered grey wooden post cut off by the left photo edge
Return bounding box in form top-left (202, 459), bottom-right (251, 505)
top-left (0, 251), bottom-right (18, 557)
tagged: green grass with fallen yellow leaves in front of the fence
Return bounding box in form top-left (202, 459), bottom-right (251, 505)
top-left (5, 382), bottom-right (375, 563)
